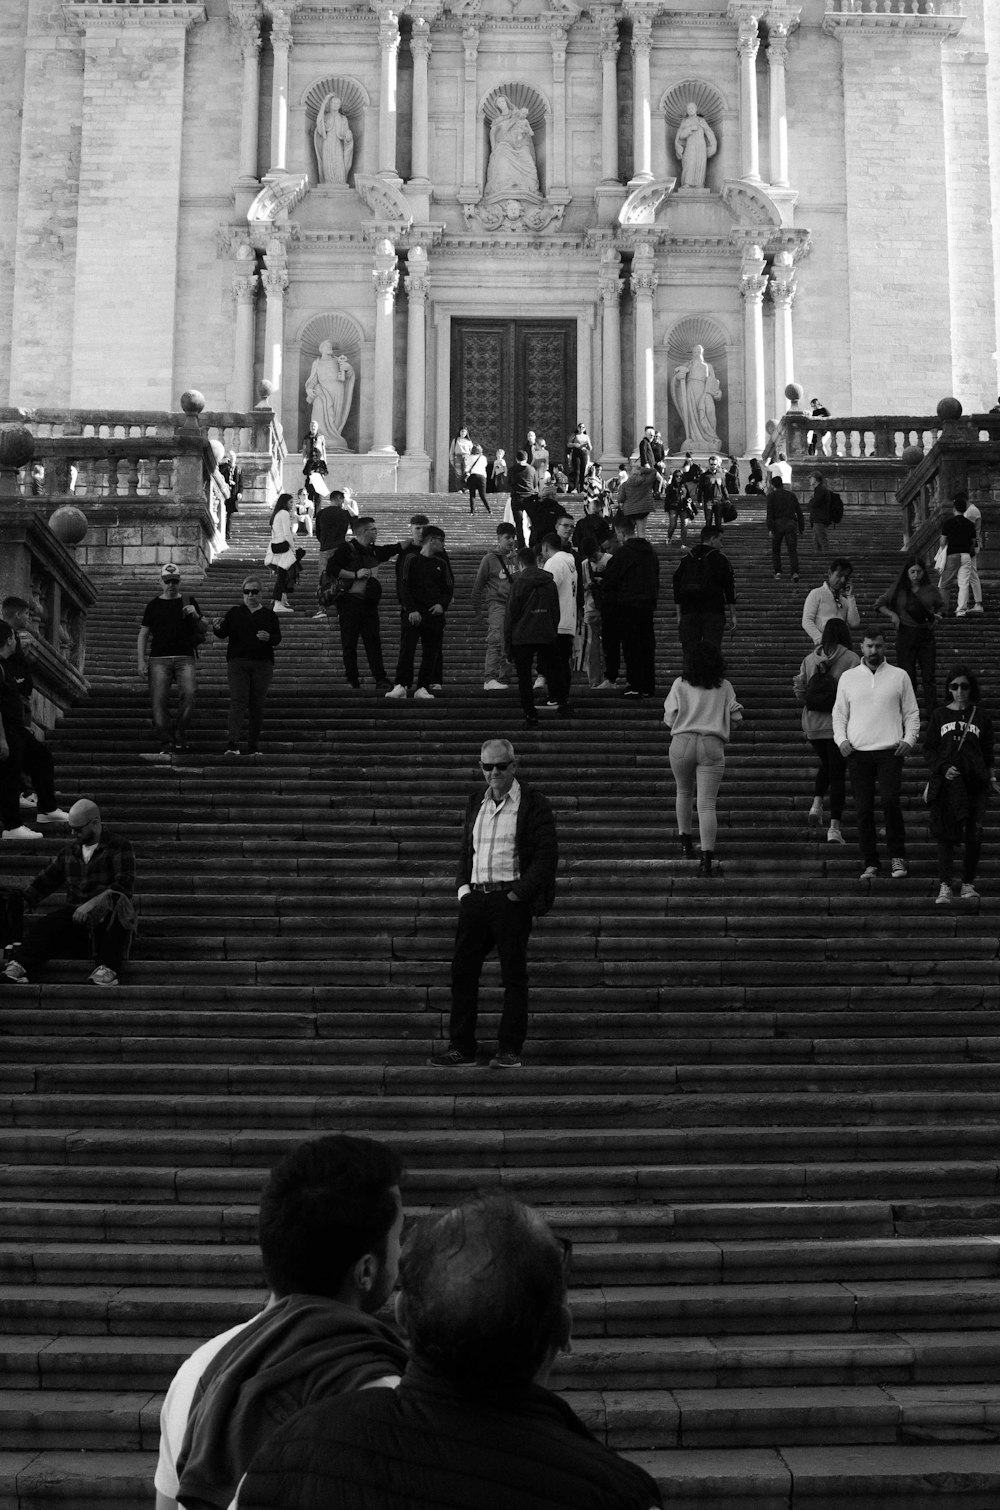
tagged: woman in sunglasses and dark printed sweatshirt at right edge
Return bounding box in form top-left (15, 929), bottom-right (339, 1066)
top-left (923, 664), bottom-right (997, 903)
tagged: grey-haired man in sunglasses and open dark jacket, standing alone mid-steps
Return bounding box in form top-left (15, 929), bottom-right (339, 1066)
top-left (427, 738), bottom-right (559, 1069)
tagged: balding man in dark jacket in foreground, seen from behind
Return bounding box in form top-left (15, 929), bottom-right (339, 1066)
top-left (237, 1194), bottom-right (662, 1510)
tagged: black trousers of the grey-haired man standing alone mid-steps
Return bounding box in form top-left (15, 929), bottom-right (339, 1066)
top-left (449, 891), bottom-right (532, 1057)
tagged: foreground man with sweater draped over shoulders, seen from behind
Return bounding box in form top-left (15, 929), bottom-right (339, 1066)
top-left (154, 1134), bottom-right (406, 1510)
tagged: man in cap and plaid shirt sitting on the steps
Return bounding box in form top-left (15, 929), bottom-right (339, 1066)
top-left (0, 797), bottom-right (136, 986)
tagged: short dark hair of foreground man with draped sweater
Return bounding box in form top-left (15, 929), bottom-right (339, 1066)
top-left (258, 1133), bottom-right (402, 1299)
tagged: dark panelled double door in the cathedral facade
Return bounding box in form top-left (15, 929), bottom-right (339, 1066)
top-left (450, 319), bottom-right (577, 486)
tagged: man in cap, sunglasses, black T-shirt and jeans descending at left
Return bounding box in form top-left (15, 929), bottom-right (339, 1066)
top-left (136, 562), bottom-right (208, 760)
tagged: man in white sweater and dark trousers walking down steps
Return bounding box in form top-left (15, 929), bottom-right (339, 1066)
top-left (834, 625), bottom-right (920, 880)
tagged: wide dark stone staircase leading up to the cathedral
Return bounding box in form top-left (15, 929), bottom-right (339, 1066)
top-left (0, 495), bottom-right (1000, 1510)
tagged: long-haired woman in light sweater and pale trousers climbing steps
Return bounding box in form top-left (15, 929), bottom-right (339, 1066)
top-left (663, 640), bottom-right (743, 876)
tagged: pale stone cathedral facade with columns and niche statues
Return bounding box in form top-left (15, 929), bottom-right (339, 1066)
top-left (0, 0), bottom-right (1000, 491)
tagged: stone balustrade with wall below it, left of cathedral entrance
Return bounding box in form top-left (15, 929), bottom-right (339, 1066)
top-left (0, 393), bottom-right (285, 574)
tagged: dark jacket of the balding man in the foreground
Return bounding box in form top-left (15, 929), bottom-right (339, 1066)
top-left (239, 1361), bottom-right (662, 1510)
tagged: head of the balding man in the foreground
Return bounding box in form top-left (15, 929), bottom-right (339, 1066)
top-left (399, 1193), bottom-right (566, 1386)
